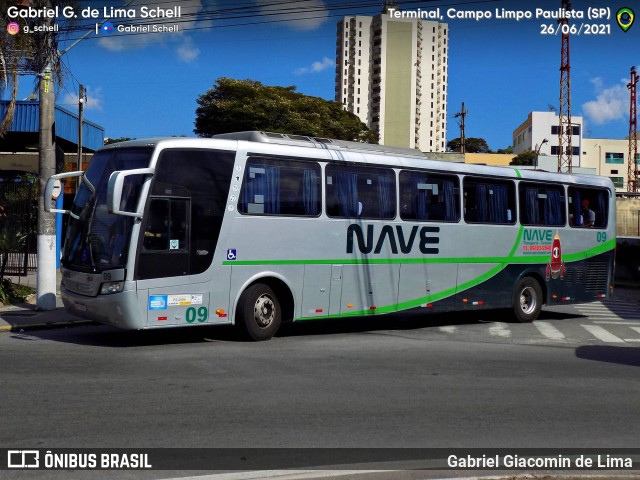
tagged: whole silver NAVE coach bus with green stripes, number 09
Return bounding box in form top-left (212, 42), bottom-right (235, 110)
top-left (45, 132), bottom-right (616, 340)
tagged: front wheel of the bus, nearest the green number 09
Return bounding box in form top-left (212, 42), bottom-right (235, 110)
top-left (236, 283), bottom-right (282, 341)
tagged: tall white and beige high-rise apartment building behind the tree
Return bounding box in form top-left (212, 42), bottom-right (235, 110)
top-left (336, 1), bottom-right (448, 152)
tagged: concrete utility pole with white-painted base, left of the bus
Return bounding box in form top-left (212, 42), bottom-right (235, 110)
top-left (36, 2), bottom-right (57, 310)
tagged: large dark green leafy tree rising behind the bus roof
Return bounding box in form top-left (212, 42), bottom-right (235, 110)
top-left (194, 77), bottom-right (378, 143)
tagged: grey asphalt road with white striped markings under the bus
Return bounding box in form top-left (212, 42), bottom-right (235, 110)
top-left (0, 302), bottom-right (640, 478)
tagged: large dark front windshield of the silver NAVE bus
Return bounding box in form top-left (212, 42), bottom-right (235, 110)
top-left (61, 148), bottom-right (152, 272)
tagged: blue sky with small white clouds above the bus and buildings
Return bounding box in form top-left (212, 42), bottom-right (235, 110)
top-left (6, 0), bottom-right (640, 150)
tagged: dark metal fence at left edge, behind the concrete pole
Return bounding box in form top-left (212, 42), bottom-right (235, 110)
top-left (0, 175), bottom-right (38, 275)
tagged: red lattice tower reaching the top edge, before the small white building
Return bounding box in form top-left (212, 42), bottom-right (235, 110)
top-left (558, 0), bottom-right (573, 173)
